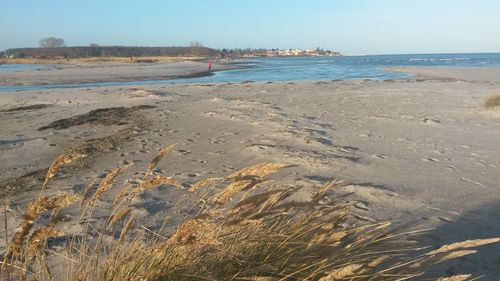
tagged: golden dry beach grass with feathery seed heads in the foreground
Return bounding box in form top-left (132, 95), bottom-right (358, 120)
top-left (0, 145), bottom-right (500, 281)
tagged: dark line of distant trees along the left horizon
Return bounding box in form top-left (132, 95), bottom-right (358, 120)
top-left (5, 45), bottom-right (217, 58)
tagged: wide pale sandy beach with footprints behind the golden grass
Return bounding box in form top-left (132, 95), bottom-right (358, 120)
top-left (0, 68), bottom-right (500, 280)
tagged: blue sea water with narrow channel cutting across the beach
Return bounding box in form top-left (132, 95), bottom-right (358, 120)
top-left (0, 53), bottom-right (500, 91)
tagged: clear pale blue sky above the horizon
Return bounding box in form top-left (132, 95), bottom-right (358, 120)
top-left (0, 0), bottom-right (500, 54)
